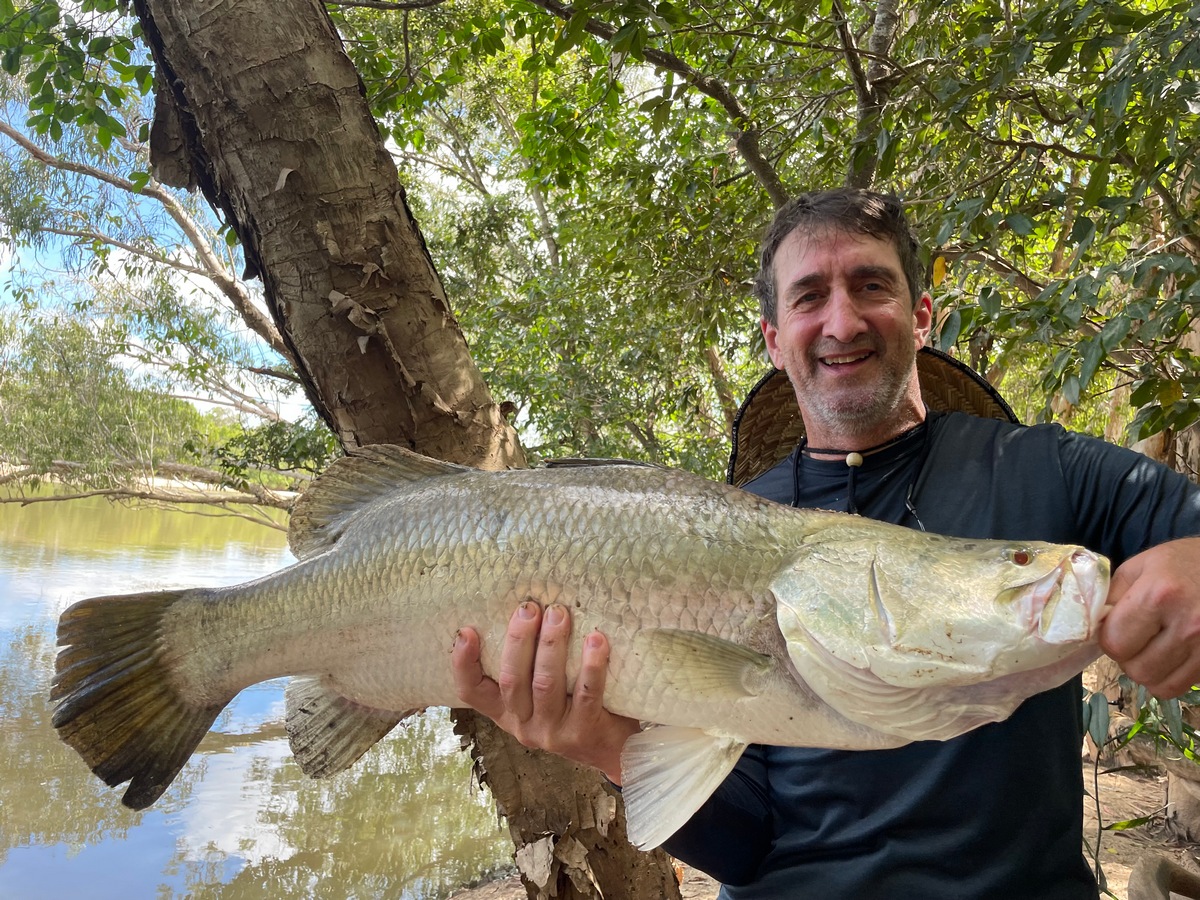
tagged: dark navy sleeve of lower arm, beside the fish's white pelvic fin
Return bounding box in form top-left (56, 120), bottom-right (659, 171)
top-left (662, 744), bottom-right (774, 886)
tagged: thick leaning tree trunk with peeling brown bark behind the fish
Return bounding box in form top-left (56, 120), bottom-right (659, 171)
top-left (129, 0), bottom-right (678, 900)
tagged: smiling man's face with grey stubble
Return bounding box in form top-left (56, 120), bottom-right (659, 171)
top-left (762, 230), bottom-right (932, 449)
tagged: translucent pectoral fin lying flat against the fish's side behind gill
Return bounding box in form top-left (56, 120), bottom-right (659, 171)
top-left (632, 628), bottom-right (774, 700)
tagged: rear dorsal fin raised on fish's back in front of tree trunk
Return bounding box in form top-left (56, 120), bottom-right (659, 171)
top-left (288, 444), bottom-right (475, 559)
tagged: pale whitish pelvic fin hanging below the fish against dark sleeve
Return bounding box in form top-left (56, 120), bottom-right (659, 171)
top-left (620, 725), bottom-right (746, 850)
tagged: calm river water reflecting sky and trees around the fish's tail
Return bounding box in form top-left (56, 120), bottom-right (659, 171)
top-left (0, 502), bottom-right (511, 900)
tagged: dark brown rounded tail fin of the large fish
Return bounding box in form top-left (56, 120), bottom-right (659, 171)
top-left (50, 589), bottom-right (233, 809)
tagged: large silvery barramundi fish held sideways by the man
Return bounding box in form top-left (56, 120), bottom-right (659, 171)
top-left (53, 445), bottom-right (1109, 847)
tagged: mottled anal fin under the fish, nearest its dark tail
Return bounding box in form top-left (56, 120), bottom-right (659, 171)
top-left (284, 677), bottom-right (416, 778)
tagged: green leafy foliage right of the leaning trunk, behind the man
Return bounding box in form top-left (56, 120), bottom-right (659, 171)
top-left (340, 0), bottom-right (1200, 452)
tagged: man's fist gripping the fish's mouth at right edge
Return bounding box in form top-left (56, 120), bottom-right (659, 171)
top-left (1099, 538), bottom-right (1200, 700)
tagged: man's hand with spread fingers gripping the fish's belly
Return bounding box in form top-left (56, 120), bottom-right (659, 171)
top-left (451, 600), bottom-right (641, 784)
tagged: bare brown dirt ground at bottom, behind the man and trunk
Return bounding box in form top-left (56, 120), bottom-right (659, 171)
top-left (454, 762), bottom-right (1200, 900)
